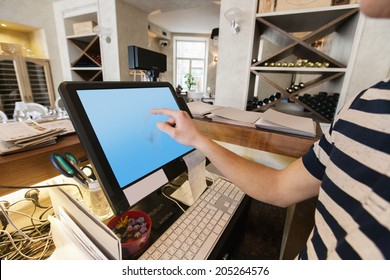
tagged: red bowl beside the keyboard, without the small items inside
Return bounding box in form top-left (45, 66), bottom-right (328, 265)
top-left (107, 210), bottom-right (152, 258)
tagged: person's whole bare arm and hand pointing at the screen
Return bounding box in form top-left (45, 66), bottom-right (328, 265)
top-left (152, 109), bottom-right (320, 207)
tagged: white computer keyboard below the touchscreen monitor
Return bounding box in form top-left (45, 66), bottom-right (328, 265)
top-left (139, 178), bottom-right (244, 260)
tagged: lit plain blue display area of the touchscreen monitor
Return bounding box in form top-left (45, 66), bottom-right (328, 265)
top-left (77, 87), bottom-right (193, 188)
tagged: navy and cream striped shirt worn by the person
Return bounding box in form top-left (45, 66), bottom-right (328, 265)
top-left (298, 80), bottom-right (390, 259)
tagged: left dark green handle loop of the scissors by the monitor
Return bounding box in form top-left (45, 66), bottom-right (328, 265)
top-left (50, 153), bottom-right (89, 188)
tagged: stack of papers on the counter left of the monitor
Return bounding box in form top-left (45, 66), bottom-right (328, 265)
top-left (0, 120), bottom-right (65, 155)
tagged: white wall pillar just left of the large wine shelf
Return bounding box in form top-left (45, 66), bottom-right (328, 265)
top-left (215, 0), bottom-right (258, 109)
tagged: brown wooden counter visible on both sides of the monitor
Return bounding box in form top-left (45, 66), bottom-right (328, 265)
top-left (0, 119), bottom-right (317, 196)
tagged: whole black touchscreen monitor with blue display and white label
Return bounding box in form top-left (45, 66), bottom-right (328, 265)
top-left (59, 82), bottom-right (193, 214)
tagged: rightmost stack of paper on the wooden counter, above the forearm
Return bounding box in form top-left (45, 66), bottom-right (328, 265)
top-left (256, 109), bottom-right (316, 137)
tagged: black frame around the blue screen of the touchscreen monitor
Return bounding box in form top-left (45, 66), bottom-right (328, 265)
top-left (58, 81), bottom-right (194, 215)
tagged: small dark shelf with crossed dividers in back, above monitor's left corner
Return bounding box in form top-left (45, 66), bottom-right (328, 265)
top-left (67, 34), bottom-right (103, 81)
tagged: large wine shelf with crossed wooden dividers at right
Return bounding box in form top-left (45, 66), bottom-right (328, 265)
top-left (250, 5), bottom-right (359, 121)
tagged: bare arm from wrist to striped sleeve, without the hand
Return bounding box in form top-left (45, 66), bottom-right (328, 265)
top-left (195, 136), bottom-right (319, 207)
